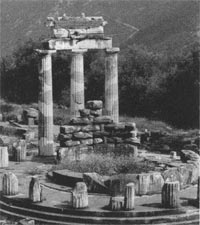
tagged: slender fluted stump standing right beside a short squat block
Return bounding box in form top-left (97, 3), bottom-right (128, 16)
top-left (124, 183), bottom-right (135, 210)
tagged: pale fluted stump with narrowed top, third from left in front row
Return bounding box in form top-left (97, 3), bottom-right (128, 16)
top-left (72, 182), bottom-right (88, 209)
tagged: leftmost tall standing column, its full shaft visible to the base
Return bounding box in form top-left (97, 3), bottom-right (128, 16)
top-left (37, 50), bottom-right (56, 156)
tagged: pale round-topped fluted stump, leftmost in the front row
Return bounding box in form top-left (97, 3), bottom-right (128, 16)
top-left (2, 172), bottom-right (18, 196)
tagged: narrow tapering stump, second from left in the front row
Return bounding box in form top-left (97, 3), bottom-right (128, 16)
top-left (29, 177), bottom-right (43, 202)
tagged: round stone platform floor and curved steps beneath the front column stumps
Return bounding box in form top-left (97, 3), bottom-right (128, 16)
top-left (0, 161), bottom-right (199, 225)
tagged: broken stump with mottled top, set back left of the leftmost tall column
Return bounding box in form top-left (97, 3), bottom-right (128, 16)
top-left (12, 139), bottom-right (26, 162)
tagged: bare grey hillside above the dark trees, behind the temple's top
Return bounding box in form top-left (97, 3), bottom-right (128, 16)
top-left (1, 0), bottom-right (199, 56)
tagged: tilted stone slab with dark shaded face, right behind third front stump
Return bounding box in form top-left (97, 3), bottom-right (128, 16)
top-left (83, 173), bottom-right (108, 193)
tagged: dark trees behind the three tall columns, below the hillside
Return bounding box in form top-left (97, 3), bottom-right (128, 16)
top-left (1, 40), bottom-right (199, 128)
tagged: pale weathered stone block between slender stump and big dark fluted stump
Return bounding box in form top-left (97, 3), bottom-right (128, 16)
top-left (138, 172), bottom-right (164, 195)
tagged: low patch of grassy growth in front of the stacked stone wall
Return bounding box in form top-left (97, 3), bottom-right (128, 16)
top-left (52, 153), bottom-right (155, 175)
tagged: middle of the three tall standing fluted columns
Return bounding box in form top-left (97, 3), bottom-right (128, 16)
top-left (70, 49), bottom-right (86, 118)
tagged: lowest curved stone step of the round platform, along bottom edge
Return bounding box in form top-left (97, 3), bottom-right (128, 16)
top-left (0, 202), bottom-right (199, 224)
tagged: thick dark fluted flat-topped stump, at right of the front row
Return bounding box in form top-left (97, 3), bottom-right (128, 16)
top-left (162, 181), bottom-right (180, 208)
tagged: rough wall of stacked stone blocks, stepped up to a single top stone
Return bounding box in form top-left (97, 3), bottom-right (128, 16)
top-left (58, 101), bottom-right (140, 160)
